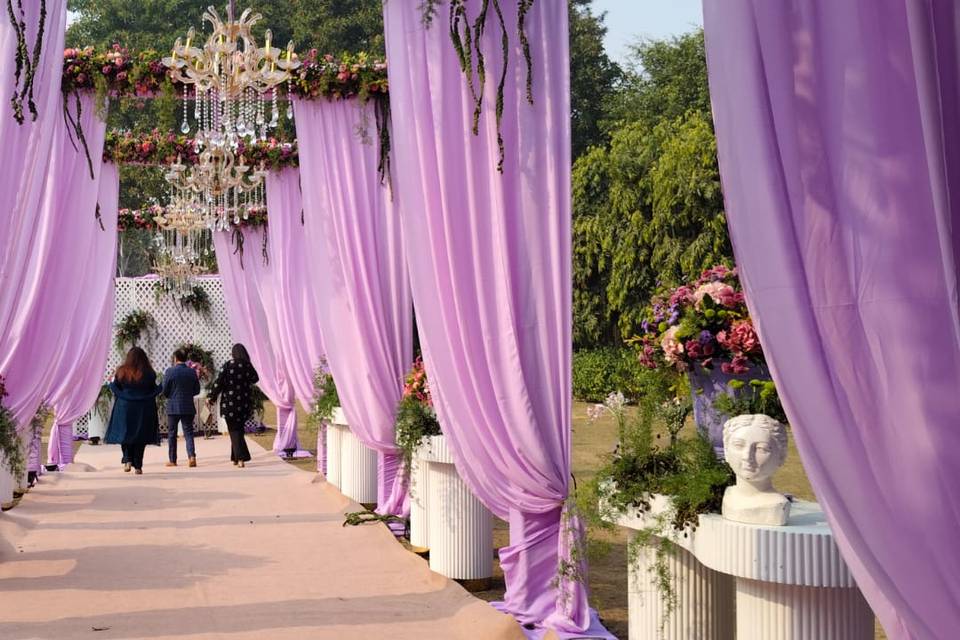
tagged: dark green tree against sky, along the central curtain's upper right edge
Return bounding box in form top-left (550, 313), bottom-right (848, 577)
top-left (570, 0), bottom-right (622, 159)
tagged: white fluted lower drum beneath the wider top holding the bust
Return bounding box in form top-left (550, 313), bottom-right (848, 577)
top-left (736, 578), bottom-right (873, 640)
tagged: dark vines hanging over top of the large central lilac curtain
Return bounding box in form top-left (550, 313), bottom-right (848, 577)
top-left (420, 0), bottom-right (534, 173)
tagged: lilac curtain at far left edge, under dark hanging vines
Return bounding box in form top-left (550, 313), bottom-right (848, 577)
top-left (0, 0), bottom-right (67, 424)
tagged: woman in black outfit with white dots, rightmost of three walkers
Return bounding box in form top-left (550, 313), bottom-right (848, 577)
top-left (207, 343), bottom-right (260, 467)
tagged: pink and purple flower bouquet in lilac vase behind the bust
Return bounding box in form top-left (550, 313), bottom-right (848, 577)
top-left (632, 265), bottom-right (766, 375)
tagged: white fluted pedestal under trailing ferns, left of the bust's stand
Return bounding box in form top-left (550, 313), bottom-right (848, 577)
top-left (628, 531), bottom-right (734, 640)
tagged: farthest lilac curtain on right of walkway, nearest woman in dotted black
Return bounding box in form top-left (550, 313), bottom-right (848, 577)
top-left (213, 229), bottom-right (305, 455)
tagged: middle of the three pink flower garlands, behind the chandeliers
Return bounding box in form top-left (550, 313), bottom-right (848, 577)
top-left (103, 129), bottom-right (300, 171)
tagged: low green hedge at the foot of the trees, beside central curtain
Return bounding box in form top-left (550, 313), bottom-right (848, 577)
top-left (573, 347), bottom-right (649, 402)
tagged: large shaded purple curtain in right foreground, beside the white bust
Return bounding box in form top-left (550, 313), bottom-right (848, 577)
top-left (704, 0), bottom-right (960, 640)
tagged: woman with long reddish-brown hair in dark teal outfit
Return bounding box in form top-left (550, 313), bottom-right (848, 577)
top-left (104, 347), bottom-right (163, 475)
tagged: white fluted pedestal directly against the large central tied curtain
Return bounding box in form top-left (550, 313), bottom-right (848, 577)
top-left (421, 436), bottom-right (493, 580)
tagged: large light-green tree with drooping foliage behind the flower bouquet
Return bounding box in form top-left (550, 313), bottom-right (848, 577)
top-left (573, 31), bottom-right (733, 347)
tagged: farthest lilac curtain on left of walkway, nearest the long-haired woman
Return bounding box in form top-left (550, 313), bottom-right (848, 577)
top-left (47, 164), bottom-right (120, 467)
